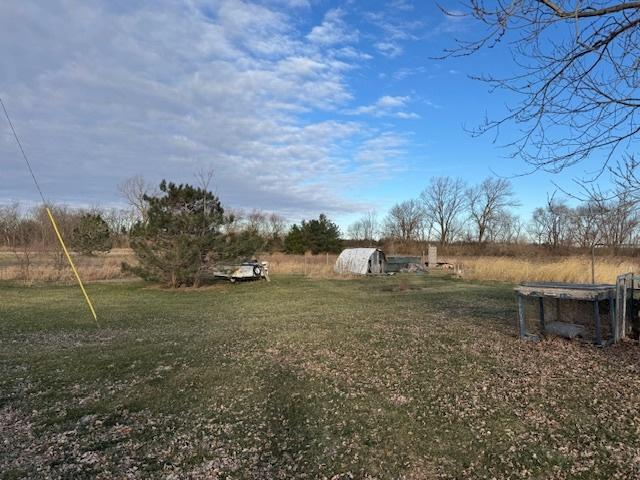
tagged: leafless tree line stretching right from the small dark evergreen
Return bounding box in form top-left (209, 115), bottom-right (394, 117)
top-left (347, 177), bottom-right (640, 248)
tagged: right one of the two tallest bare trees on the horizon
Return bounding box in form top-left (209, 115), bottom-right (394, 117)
top-left (467, 177), bottom-right (518, 243)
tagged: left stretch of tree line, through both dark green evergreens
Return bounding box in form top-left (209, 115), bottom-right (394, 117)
top-left (0, 178), bottom-right (342, 287)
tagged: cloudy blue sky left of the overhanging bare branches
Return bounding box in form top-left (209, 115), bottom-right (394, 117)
top-left (0, 0), bottom-right (608, 229)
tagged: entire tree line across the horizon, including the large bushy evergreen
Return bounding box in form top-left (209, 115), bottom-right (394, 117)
top-left (0, 174), bottom-right (640, 286)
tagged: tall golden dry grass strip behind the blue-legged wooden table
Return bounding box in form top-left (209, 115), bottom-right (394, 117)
top-left (456, 256), bottom-right (640, 283)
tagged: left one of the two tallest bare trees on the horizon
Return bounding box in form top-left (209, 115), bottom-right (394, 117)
top-left (420, 177), bottom-right (466, 245)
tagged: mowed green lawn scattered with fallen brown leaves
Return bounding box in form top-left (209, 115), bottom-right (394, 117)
top-left (0, 275), bottom-right (640, 479)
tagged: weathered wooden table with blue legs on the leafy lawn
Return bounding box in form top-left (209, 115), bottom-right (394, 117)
top-left (515, 282), bottom-right (618, 345)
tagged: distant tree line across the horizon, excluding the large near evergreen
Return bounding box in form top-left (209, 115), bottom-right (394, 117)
top-left (0, 172), bottom-right (640, 256)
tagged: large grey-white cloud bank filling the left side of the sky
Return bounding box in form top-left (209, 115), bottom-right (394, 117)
top-left (0, 0), bottom-right (414, 219)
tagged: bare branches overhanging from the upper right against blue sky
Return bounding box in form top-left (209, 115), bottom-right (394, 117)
top-left (445, 0), bottom-right (640, 173)
